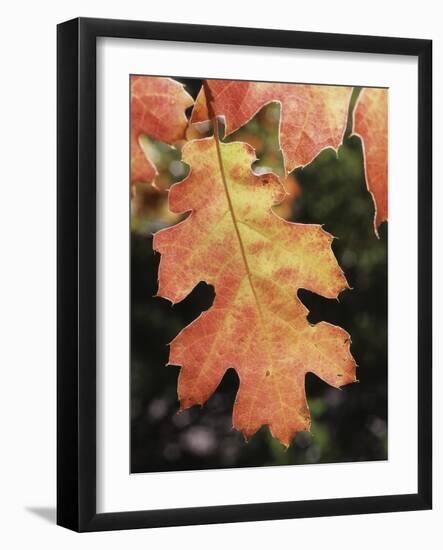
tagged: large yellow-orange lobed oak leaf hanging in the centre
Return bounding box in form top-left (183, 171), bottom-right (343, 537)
top-left (153, 137), bottom-right (356, 446)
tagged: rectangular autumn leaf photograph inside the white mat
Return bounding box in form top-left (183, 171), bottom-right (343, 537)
top-left (128, 74), bottom-right (389, 474)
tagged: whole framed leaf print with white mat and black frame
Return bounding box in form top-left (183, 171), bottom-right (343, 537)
top-left (57, 19), bottom-right (432, 531)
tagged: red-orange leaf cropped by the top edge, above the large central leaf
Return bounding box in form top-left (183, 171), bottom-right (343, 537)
top-left (191, 80), bottom-right (352, 173)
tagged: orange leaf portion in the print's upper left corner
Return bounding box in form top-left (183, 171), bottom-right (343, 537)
top-left (131, 76), bottom-right (194, 188)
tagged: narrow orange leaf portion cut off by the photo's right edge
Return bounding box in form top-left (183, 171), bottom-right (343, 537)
top-left (353, 88), bottom-right (388, 236)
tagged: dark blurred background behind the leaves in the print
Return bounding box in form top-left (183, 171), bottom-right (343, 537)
top-left (131, 79), bottom-right (387, 473)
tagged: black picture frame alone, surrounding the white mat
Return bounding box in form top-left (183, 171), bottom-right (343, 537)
top-left (57, 18), bottom-right (432, 531)
